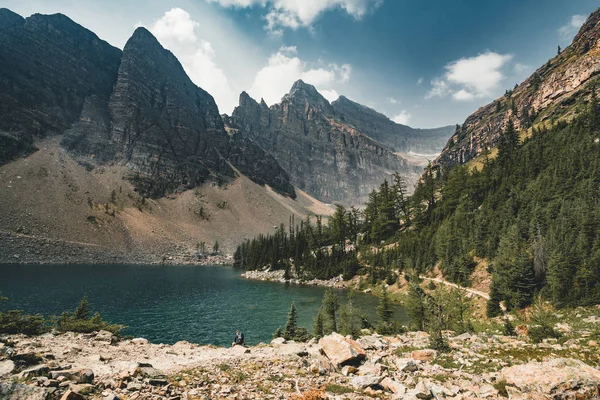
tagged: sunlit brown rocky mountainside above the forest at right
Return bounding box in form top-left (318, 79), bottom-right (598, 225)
top-left (436, 10), bottom-right (600, 166)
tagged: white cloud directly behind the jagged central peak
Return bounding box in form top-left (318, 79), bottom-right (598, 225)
top-left (248, 47), bottom-right (352, 105)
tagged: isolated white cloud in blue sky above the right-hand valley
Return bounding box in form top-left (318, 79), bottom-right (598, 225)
top-left (425, 51), bottom-right (512, 101)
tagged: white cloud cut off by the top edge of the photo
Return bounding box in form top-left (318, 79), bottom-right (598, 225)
top-left (206, 0), bottom-right (383, 35)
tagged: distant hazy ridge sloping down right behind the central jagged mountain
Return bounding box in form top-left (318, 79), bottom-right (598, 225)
top-left (331, 96), bottom-right (455, 154)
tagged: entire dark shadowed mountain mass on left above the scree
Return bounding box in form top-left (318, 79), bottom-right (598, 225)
top-left (0, 9), bottom-right (295, 197)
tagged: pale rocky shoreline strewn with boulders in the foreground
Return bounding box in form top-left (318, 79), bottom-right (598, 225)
top-left (0, 324), bottom-right (600, 400)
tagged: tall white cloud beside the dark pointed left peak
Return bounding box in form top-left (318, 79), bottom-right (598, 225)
top-left (149, 8), bottom-right (237, 112)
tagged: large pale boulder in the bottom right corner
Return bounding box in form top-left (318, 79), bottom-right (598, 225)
top-left (501, 358), bottom-right (600, 398)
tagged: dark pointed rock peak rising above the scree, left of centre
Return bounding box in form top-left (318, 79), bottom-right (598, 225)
top-left (66, 28), bottom-right (233, 197)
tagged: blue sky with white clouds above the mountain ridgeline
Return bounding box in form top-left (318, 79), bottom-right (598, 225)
top-left (0, 0), bottom-right (599, 128)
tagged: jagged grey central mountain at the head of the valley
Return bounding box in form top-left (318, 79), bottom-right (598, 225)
top-left (225, 80), bottom-right (420, 205)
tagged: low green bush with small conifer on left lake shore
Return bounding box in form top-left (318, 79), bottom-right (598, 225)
top-left (56, 296), bottom-right (125, 336)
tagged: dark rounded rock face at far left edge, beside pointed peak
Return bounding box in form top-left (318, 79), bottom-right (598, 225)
top-left (0, 9), bottom-right (121, 164)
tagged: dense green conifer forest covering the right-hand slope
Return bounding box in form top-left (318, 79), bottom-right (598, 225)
top-left (235, 94), bottom-right (600, 316)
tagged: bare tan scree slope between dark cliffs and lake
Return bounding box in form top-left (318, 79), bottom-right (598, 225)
top-left (0, 137), bottom-right (331, 264)
